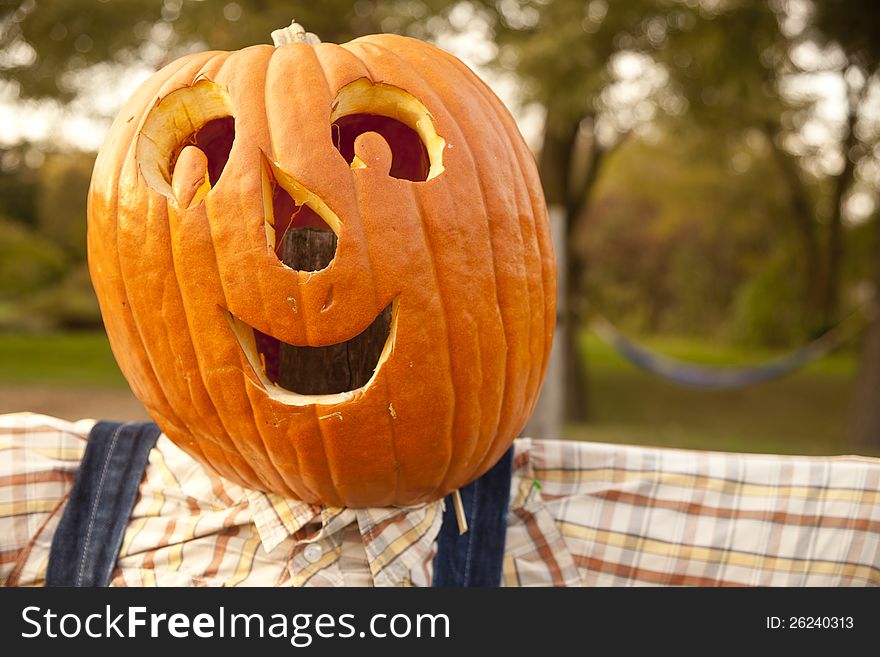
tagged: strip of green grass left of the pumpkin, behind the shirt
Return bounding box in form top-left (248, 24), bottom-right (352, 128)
top-left (0, 332), bottom-right (126, 388)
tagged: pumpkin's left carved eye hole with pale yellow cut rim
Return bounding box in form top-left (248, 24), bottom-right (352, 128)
top-left (137, 80), bottom-right (235, 208)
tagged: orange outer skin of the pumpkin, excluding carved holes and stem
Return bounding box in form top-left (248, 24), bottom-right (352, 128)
top-left (88, 35), bottom-right (556, 507)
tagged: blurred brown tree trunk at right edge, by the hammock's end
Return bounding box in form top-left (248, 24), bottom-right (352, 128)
top-left (850, 217), bottom-right (880, 451)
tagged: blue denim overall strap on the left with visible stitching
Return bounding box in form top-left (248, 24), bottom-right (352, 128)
top-left (46, 422), bottom-right (160, 586)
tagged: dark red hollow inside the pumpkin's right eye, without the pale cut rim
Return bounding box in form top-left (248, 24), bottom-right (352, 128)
top-left (333, 114), bottom-right (431, 182)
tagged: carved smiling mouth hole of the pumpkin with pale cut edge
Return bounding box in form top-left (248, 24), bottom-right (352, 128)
top-left (222, 297), bottom-right (400, 406)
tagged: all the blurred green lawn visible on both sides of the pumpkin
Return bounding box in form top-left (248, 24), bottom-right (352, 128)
top-left (0, 333), bottom-right (880, 455)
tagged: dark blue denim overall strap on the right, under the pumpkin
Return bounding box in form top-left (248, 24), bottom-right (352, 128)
top-left (433, 447), bottom-right (513, 586)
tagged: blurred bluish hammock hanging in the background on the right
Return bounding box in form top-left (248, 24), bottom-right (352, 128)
top-left (590, 306), bottom-right (871, 390)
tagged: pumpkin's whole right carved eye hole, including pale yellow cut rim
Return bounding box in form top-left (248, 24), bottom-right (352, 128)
top-left (330, 78), bottom-right (446, 182)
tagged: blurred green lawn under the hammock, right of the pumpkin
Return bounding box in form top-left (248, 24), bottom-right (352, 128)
top-left (565, 336), bottom-right (880, 455)
